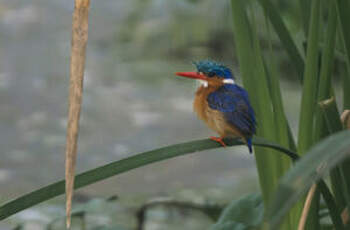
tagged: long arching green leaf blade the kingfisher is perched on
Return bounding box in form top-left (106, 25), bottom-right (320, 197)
top-left (0, 137), bottom-right (298, 220)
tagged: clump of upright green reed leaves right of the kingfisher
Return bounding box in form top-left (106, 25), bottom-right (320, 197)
top-left (231, 0), bottom-right (349, 229)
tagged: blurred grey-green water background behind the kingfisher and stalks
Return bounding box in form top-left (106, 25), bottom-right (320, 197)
top-left (0, 0), bottom-right (342, 229)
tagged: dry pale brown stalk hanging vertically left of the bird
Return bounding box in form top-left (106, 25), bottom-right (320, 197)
top-left (66, 0), bottom-right (90, 228)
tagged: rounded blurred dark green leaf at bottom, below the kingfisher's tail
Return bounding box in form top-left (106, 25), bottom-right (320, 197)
top-left (211, 194), bottom-right (264, 230)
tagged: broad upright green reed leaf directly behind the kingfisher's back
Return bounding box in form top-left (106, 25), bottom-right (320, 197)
top-left (231, 0), bottom-right (290, 211)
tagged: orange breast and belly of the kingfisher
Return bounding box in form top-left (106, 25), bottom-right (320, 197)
top-left (193, 86), bottom-right (243, 137)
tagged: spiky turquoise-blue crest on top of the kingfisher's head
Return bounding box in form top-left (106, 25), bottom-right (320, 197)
top-left (193, 60), bottom-right (234, 79)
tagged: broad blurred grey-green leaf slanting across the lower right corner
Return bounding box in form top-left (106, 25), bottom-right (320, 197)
top-left (265, 131), bottom-right (350, 229)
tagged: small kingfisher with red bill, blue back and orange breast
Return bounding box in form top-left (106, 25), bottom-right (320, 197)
top-left (176, 60), bottom-right (256, 153)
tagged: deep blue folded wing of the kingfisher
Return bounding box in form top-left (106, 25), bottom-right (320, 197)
top-left (207, 84), bottom-right (256, 137)
